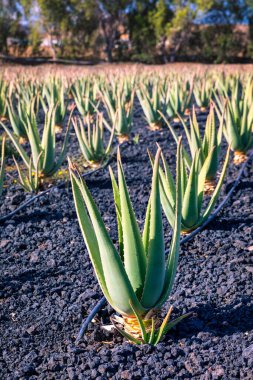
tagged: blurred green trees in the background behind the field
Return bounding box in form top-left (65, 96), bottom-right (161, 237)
top-left (0, 0), bottom-right (253, 63)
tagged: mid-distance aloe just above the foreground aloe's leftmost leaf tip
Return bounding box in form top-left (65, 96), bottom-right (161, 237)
top-left (72, 113), bottom-right (114, 167)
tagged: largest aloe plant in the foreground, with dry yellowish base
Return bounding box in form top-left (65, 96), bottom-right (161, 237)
top-left (69, 144), bottom-right (190, 345)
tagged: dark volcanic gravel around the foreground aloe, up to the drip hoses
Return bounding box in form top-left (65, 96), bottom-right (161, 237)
top-left (0, 107), bottom-right (253, 380)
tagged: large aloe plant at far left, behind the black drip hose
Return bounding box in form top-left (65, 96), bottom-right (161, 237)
top-left (1, 107), bottom-right (70, 189)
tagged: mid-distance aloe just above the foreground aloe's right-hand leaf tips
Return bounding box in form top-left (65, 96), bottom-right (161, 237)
top-left (136, 83), bottom-right (166, 130)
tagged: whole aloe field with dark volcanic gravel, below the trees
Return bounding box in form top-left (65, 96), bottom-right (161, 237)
top-left (0, 64), bottom-right (253, 380)
